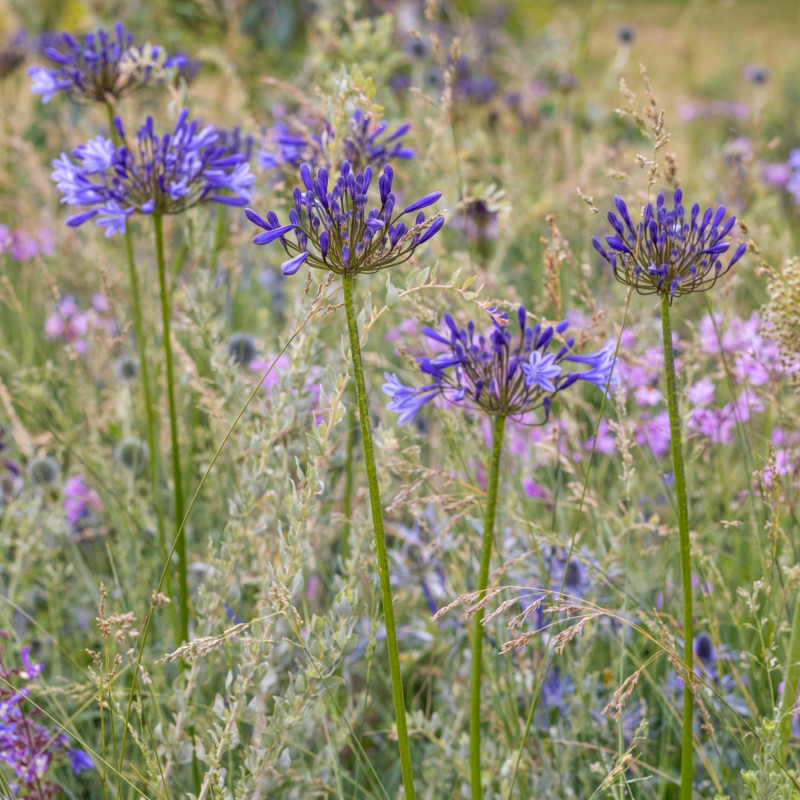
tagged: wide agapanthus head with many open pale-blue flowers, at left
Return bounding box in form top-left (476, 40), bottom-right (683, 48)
top-left (51, 109), bottom-right (255, 236)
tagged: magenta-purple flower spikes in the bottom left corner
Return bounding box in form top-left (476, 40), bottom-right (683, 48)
top-left (0, 631), bottom-right (93, 800)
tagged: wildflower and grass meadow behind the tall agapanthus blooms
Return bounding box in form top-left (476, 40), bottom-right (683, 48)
top-left (0, 0), bottom-right (800, 800)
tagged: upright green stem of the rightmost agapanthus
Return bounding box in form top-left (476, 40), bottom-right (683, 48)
top-left (661, 294), bottom-right (694, 800)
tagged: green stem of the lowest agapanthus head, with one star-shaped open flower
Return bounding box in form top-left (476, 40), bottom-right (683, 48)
top-left (469, 414), bottom-right (506, 800)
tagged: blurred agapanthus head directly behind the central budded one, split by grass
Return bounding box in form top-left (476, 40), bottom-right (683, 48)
top-left (256, 109), bottom-right (416, 171)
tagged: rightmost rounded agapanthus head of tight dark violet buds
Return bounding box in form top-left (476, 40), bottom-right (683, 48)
top-left (592, 189), bottom-right (747, 303)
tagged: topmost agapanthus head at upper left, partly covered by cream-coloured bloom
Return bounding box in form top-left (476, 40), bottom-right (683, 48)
top-left (28, 22), bottom-right (187, 103)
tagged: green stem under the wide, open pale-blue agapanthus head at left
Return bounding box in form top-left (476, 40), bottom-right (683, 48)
top-left (153, 214), bottom-right (189, 642)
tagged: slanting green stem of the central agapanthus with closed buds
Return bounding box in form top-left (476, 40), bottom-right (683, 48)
top-left (342, 275), bottom-right (415, 800)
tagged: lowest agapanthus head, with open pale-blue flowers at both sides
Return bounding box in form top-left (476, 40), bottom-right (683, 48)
top-left (383, 306), bottom-right (615, 425)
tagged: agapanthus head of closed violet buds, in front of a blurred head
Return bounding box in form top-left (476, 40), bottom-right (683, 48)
top-left (245, 161), bottom-right (444, 277)
